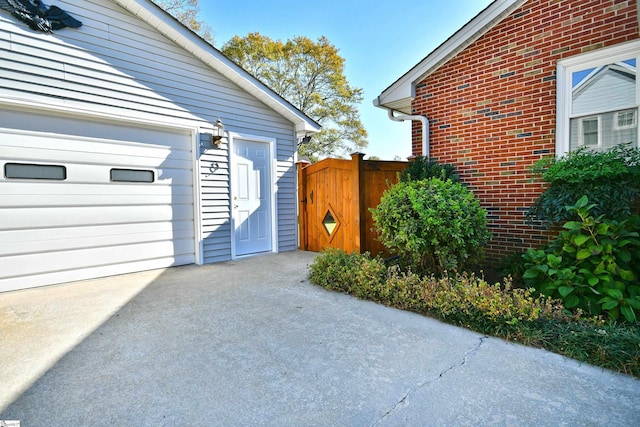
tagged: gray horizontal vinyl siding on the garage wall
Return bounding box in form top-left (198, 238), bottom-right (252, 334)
top-left (0, 0), bottom-right (297, 262)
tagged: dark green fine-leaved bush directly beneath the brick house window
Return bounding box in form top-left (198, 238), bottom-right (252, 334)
top-left (526, 144), bottom-right (640, 226)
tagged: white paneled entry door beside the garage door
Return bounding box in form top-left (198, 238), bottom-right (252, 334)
top-left (232, 139), bottom-right (273, 256)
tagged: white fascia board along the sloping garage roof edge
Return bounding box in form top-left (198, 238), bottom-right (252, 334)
top-left (112, 0), bottom-right (321, 133)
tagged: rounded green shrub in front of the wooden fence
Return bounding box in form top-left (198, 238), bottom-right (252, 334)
top-left (370, 178), bottom-right (491, 274)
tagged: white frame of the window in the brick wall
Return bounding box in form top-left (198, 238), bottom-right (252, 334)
top-left (556, 40), bottom-right (640, 157)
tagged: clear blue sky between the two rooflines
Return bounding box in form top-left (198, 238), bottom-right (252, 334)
top-left (200, 0), bottom-right (491, 160)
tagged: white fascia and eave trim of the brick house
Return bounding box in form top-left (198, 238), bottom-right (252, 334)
top-left (374, 0), bottom-right (527, 114)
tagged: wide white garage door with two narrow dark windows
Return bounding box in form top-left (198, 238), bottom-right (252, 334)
top-left (0, 111), bottom-right (195, 291)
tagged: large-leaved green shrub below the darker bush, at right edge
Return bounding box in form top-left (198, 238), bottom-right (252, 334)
top-left (523, 196), bottom-right (640, 322)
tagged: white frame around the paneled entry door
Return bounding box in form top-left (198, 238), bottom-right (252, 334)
top-left (227, 132), bottom-right (278, 259)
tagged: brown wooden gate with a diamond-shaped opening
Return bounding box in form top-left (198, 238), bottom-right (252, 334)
top-left (298, 153), bottom-right (407, 256)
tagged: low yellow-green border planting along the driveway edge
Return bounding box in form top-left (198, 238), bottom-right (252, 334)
top-left (309, 249), bottom-right (640, 378)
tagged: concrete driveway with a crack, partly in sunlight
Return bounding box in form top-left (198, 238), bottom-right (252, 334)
top-left (0, 252), bottom-right (640, 427)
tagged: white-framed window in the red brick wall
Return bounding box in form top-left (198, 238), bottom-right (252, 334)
top-left (556, 41), bottom-right (640, 156)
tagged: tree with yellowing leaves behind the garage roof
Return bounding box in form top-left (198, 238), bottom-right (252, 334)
top-left (222, 32), bottom-right (367, 161)
